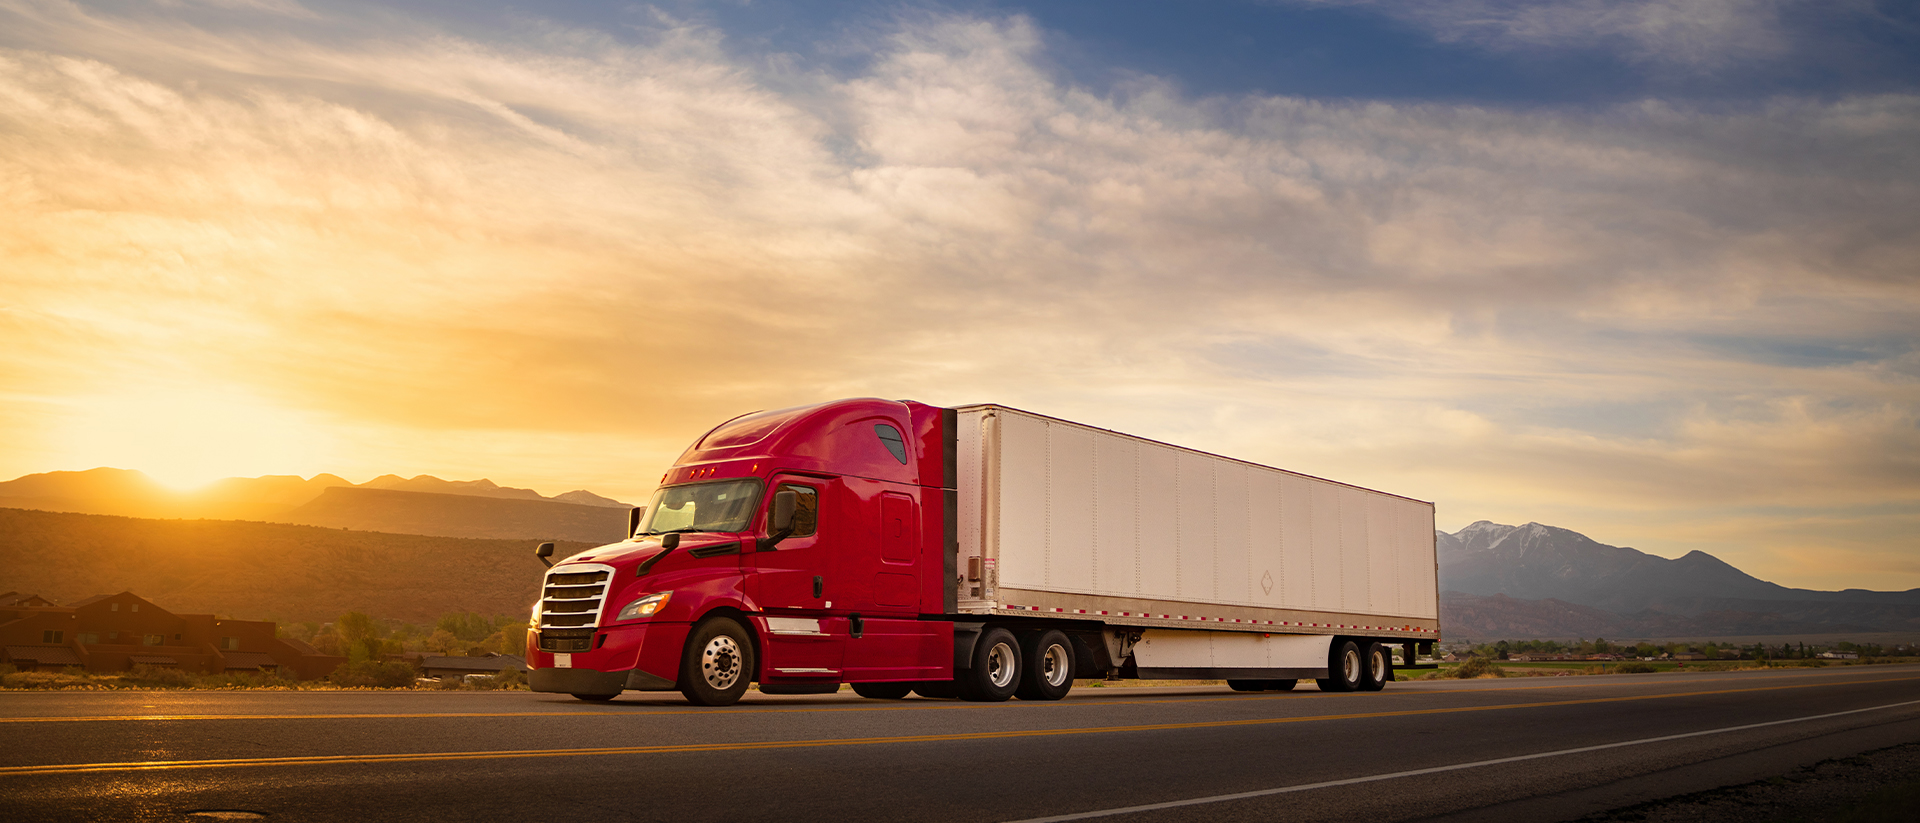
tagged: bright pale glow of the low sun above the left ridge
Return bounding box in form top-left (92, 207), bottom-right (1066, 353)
top-left (60, 388), bottom-right (332, 491)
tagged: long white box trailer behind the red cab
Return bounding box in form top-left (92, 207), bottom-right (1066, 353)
top-left (950, 405), bottom-right (1440, 691)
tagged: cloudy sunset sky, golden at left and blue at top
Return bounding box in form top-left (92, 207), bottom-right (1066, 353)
top-left (0, 0), bottom-right (1920, 589)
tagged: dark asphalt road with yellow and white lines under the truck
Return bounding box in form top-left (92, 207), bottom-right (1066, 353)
top-left (0, 666), bottom-right (1920, 823)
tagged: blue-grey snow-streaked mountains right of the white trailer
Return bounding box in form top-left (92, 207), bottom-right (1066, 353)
top-left (1434, 520), bottom-right (1920, 639)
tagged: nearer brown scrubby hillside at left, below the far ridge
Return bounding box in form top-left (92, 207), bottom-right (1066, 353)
top-left (0, 508), bottom-right (593, 623)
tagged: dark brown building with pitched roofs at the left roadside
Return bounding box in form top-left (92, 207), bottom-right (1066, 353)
top-left (0, 591), bottom-right (346, 679)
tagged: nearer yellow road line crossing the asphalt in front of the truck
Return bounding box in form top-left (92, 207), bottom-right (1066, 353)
top-left (0, 677), bottom-right (1912, 777)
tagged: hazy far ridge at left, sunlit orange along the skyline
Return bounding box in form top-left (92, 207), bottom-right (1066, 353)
top-left (0, 468), bottom-right (630, 541)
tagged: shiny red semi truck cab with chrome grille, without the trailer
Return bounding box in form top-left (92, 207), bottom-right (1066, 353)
top-left (528, 399), bottom-right (954, 704)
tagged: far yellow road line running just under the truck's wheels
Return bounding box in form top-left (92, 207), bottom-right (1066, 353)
top-left (0, 671), bottom-right (1899, 723)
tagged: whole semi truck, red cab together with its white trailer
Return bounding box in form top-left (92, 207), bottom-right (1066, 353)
top-left (526, 399), bottom-right (1440, 706)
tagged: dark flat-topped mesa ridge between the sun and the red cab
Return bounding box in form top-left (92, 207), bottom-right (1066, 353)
top-left (276, 487), bottom-right (628, 545)
